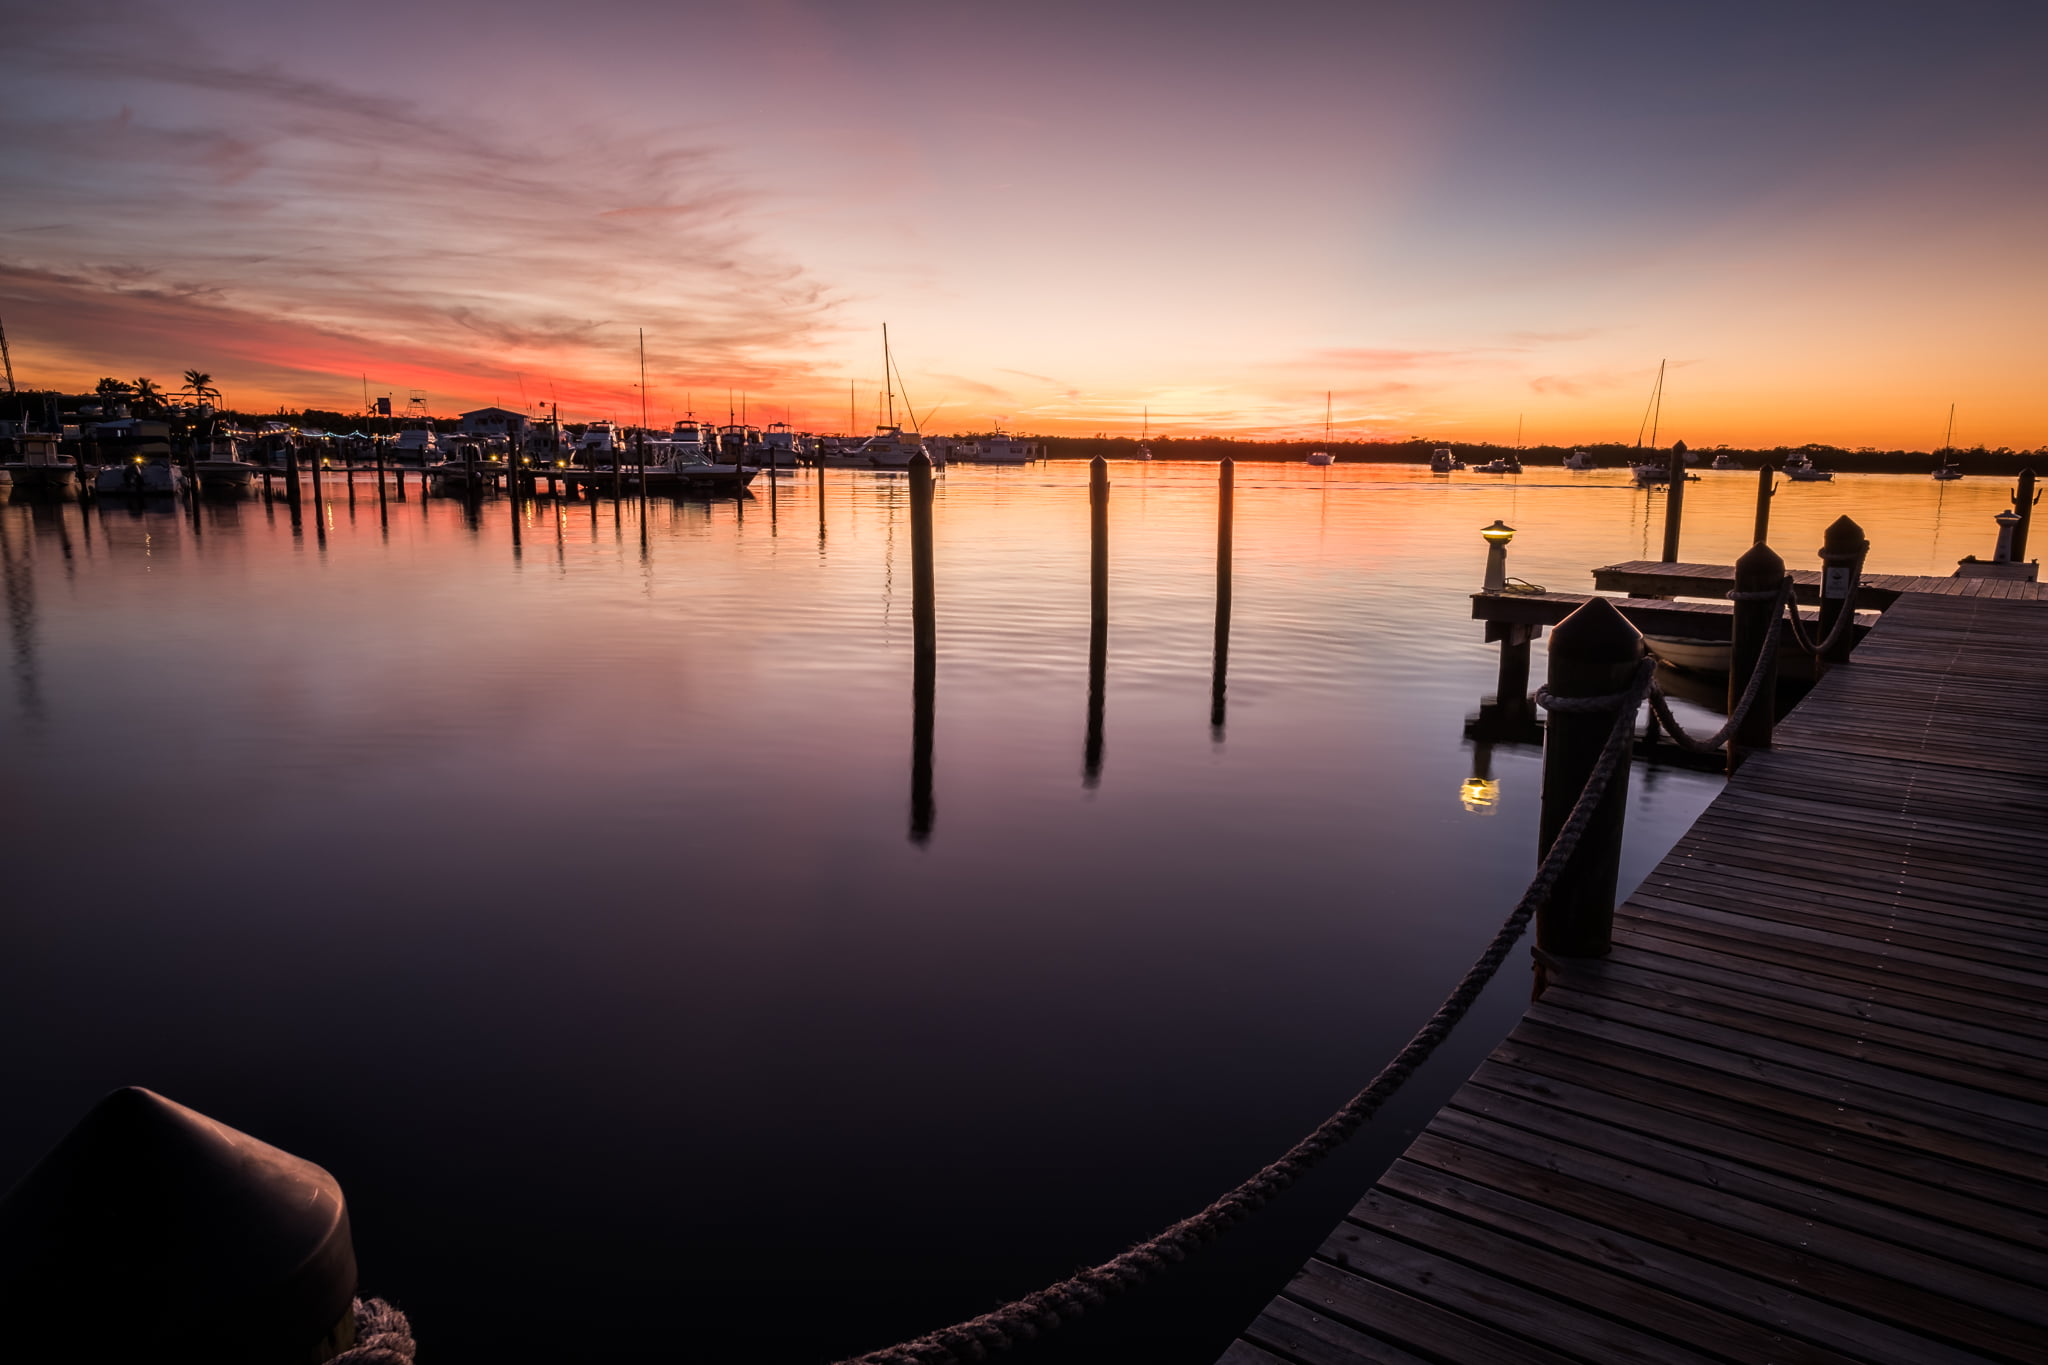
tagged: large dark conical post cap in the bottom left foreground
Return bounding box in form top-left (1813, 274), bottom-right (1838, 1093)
top-left (0, 1087), bottom-right (356, 1365)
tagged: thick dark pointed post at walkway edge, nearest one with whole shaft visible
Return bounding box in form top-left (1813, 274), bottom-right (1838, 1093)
top-left (1536, 598), bottom-right (1645, 958)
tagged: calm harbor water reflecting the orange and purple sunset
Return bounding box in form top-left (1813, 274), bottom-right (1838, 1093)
top-left (0, 463), bottom-right (2007, 1365)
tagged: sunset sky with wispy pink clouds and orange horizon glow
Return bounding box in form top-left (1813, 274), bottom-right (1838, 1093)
top-left (0, 0), bottom-right (2048, 450)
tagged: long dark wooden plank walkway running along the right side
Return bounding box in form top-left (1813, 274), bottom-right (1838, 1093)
top-left (1223, 593), bottom-right (2048, 1365)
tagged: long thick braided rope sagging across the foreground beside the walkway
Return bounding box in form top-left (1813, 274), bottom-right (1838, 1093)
top-left (838, 659), bottom-right (1657, 1365)
